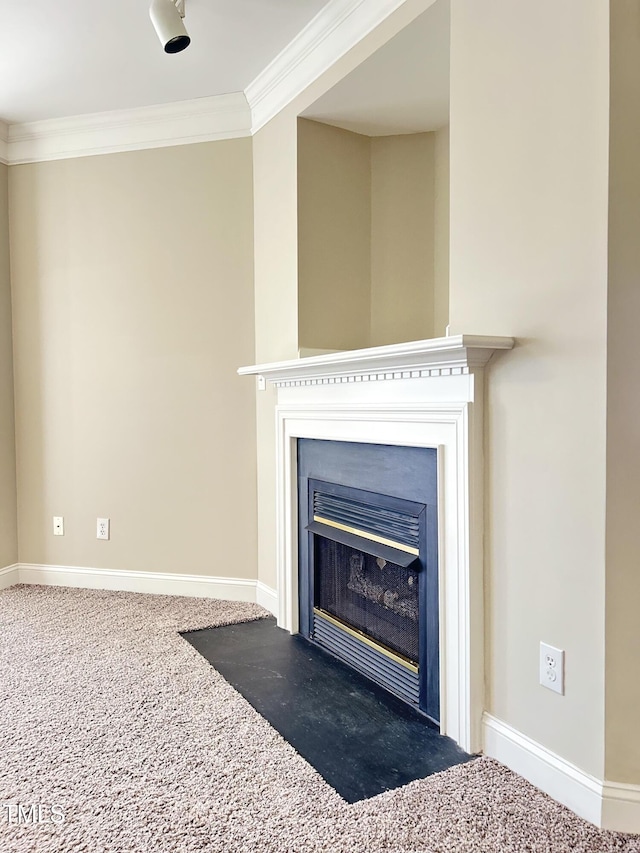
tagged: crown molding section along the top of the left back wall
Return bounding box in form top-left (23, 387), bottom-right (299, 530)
top-left (7, 92), bottom-right (251, 165)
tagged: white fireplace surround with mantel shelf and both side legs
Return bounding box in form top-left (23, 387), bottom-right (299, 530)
top-left (238, 335), bottom-right (514, 752)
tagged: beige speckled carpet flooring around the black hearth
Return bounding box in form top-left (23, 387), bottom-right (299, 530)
top-left (0, 586), bottom-right (640, 853)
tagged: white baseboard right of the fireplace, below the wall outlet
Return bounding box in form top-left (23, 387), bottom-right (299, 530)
top-left (482, 713), bottom-right (640, 832)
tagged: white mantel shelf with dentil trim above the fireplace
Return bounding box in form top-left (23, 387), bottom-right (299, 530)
top-left (238, 335), bottom-right (515, 385)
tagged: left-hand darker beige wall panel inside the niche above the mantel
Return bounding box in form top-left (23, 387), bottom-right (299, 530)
top-left (298, 119), bottom-right (374, 350)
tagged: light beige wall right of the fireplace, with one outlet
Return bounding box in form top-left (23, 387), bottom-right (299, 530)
top-left (450, 0), bottom-right (609, 778)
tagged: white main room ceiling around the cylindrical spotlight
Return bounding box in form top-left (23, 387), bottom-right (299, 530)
top-left (0, 0), bottom-right (328, 124)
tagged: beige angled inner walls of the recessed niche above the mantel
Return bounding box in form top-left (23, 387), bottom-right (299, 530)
top-left (298, 119), bottom-right (440, 349)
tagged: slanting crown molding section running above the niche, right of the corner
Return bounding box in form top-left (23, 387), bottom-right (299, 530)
top-left (245, 0), bottom-right (416, 133)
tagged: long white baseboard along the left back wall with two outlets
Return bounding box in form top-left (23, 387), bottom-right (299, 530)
top-left (14, 563), bottom-right (256, 602)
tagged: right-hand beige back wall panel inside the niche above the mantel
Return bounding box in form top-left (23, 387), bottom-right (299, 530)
top-left (371, 133), bottom-right (435, 346)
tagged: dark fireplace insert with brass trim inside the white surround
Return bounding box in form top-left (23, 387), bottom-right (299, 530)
top-left (297, 439), bottom-right (440, 724)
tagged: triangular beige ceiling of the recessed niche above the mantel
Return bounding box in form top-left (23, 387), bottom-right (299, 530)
top-left (303, 0), bottom-right (450, 136)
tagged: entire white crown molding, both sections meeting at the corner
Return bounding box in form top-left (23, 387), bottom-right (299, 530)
top-left (0, 0), bottom-right (429, 161)
